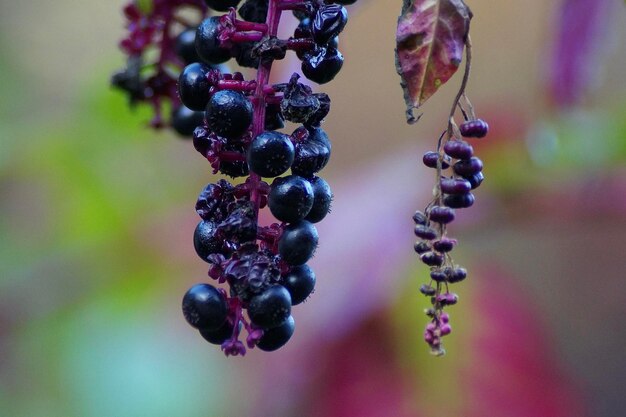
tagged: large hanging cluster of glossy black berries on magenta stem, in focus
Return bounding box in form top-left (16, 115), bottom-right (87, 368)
top-left (178, 0), bottom-right (354, 356)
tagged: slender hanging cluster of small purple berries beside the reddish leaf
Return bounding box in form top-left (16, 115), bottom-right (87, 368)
top-left (413, 37), bottom-right (489, 355)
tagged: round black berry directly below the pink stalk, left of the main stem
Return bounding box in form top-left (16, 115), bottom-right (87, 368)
top-left (205, 90), bottom-right (252, 139)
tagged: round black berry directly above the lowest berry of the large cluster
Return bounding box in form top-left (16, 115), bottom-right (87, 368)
top-left (248, 285), bottom-right (291, 329)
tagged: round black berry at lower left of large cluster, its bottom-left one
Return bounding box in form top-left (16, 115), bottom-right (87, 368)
top-left (182, 284), bottom-right (228, 330)
